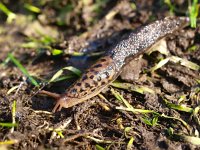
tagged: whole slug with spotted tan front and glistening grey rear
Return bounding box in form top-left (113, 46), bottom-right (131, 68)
top-left (41, 17), bottom-right (189, 112)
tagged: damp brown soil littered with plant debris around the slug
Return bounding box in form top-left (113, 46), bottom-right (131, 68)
top-left (0, 0), bottom-right (200, 150)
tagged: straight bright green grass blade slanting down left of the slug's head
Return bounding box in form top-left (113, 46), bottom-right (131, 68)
top-left (8, 53), bottom-right (39, 87)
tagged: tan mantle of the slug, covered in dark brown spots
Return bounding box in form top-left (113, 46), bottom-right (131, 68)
top-left (69, 56), bottom-right (117, 98)
